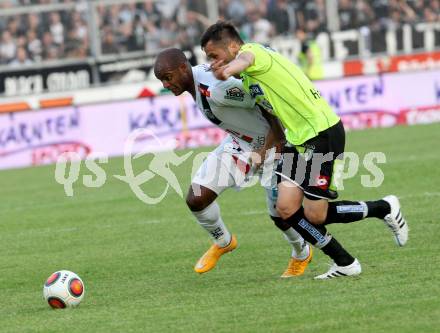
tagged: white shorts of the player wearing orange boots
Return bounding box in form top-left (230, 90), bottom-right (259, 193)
top-left (191, 136), bottom-right (278, 216)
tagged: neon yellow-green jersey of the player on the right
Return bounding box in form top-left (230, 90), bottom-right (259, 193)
top-left (240, 43), bottom-right (339, 145)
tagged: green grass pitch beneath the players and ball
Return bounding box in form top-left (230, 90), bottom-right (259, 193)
top-left (0, 124), bottom-right (440, 333)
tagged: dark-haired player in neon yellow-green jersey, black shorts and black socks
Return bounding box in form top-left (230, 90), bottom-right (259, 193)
top-left (201, 21), bottom-right (408, 279)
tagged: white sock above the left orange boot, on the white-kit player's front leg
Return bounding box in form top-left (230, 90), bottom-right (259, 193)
top-left (192, 201), bottom-right (231, 247)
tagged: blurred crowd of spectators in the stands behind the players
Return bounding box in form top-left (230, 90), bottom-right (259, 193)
top-left (0, 0), bottom-right (440, 66)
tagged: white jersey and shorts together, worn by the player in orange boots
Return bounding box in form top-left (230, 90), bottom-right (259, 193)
top-left (191, 65), bottom-right (278, 216)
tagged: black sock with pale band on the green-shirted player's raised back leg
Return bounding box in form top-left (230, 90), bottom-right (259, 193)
top-left (324, 200), bottom-right (367, 224)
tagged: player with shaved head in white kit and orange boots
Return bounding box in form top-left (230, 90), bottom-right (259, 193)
top-left (154, 48), bottom-right (312, 277)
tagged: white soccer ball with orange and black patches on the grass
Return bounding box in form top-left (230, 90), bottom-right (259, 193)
top-left (43, 270), bottom-right (85, 309)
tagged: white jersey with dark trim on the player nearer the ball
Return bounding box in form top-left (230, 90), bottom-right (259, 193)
top-left (192, 65), bottom-right (269, 150)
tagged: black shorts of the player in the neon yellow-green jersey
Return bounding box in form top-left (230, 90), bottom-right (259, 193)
top-left (276, 121), bottom-right (345, 200)
